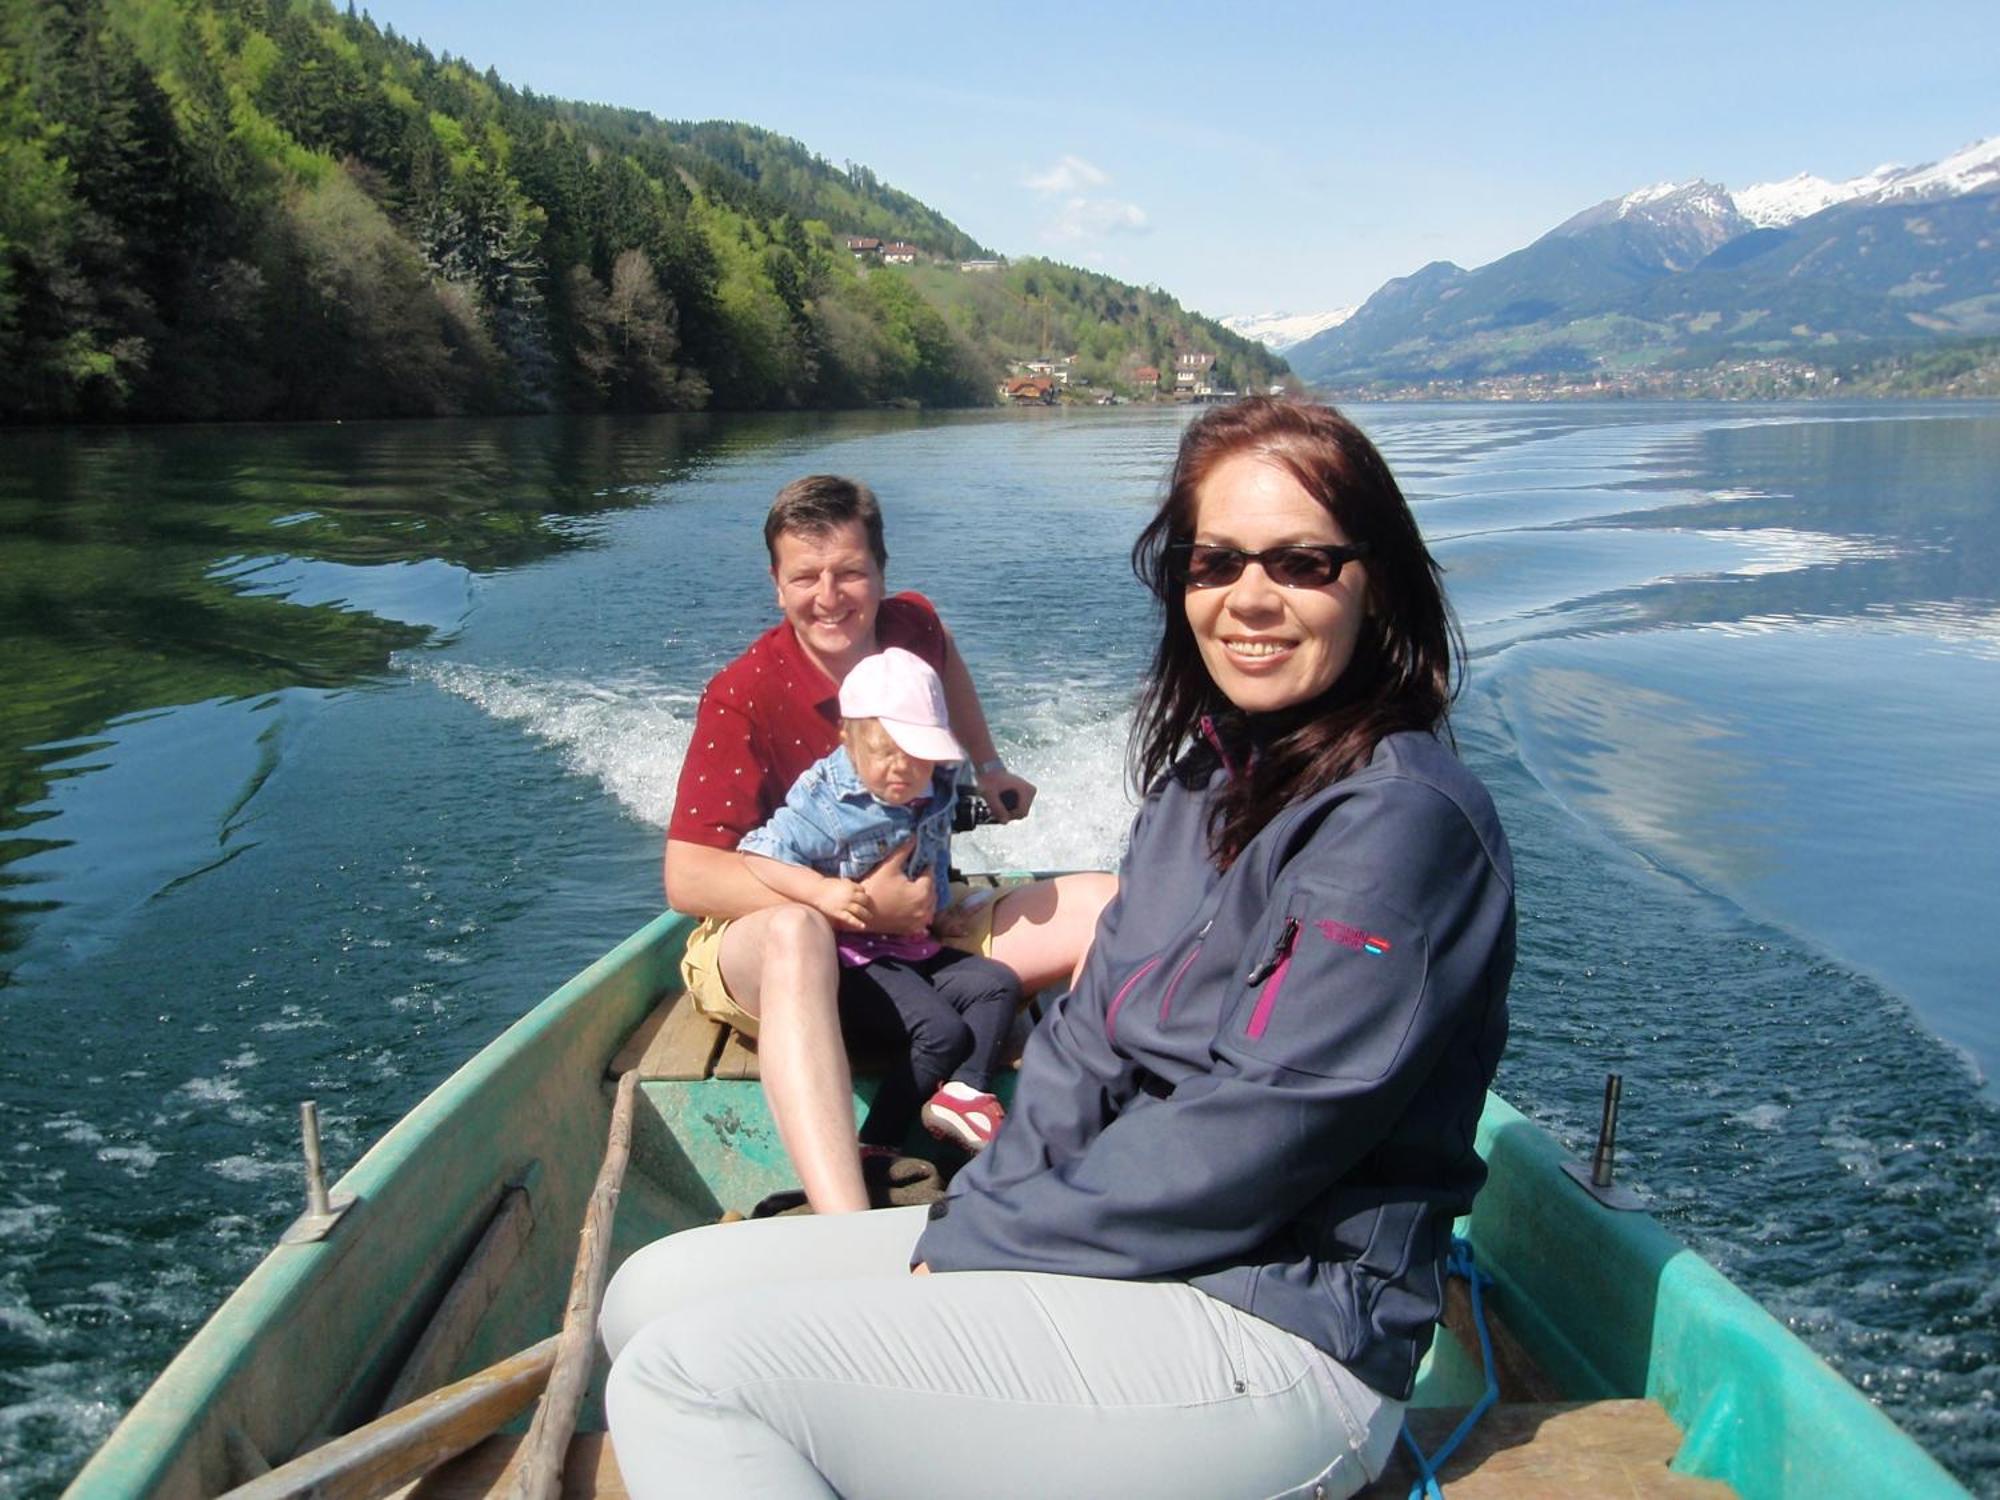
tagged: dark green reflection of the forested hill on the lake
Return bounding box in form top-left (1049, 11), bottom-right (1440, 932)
top-left (0, 416), bottom-right (760, 984)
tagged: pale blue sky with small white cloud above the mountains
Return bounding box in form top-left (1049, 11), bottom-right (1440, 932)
top-left (368, 0), bottom-right (2000, 316)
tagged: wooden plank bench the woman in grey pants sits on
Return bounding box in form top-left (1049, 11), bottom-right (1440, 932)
top-left (406, 1400), bottom-right (1734, 1500)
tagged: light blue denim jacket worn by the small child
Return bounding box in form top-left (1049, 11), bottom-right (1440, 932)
top-left (736, 746), bottom-right (958, 924)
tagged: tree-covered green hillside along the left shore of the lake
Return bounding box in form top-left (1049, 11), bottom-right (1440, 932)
top-left (0, 0), bottom-right (1282, 422)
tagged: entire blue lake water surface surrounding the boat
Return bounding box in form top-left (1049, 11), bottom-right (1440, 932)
top-left (0, 406), bottom-right (2000, 1496)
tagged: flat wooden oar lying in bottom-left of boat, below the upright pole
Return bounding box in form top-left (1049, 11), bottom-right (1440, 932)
top-left (224, 1336), bottom-right (560, 1500)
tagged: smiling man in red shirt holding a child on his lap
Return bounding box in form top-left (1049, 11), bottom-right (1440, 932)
top-left (666, 474), bottom-right (1116, 1214)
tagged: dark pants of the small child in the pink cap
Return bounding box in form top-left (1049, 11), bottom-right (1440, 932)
top-left (840, 948), bottom-right (1020, 1146)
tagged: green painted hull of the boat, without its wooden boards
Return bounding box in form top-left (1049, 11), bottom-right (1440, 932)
top-left (70, 912), bottom-right (1966, 1500)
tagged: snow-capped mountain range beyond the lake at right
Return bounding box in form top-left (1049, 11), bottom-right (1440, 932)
top-left (1286, 136), bottom-right (2000, 382)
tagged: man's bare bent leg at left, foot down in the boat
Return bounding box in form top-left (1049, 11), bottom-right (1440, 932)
top-left (718, 906), bottom-right (868, 1214)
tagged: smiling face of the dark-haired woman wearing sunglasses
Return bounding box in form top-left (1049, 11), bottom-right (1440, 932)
top-left (1182, 454), bottom-right (1368, 714)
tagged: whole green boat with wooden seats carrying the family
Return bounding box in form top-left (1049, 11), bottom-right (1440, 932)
top-left (68, 912), bottom-right (1966, 1500)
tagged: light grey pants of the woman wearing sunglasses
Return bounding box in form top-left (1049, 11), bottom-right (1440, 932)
top-left (600, 1208), bottom-right (1402, 1500)
